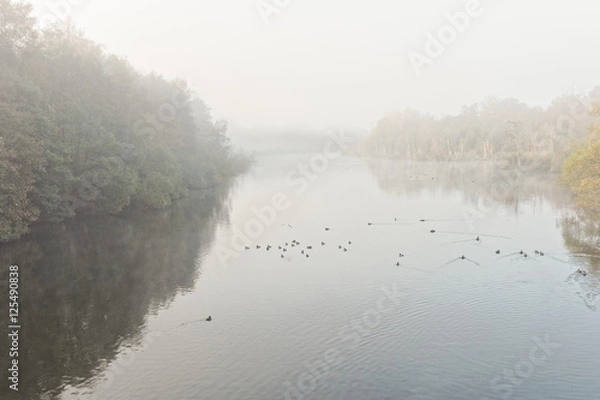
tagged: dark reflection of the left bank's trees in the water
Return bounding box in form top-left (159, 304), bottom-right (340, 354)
top-left (0, 187), bottom-right (229, 399)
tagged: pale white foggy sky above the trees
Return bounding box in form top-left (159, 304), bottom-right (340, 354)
top-left (33, 0), bottom-right (600, 128)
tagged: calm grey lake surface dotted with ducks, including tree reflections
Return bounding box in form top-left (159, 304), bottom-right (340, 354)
top-left (0, 155), bottom-right (600, 400)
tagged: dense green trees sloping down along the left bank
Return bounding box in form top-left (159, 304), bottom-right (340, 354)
top-left (0, 0), bottom-right (247, 242)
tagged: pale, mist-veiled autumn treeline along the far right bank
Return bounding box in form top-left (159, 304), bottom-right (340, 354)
top-left (358, 94), bottom-right (600, 171)
